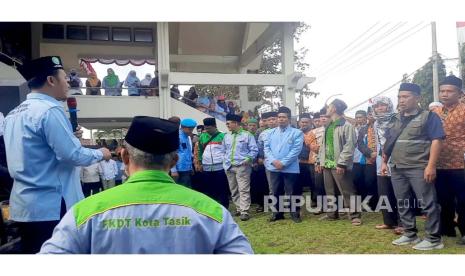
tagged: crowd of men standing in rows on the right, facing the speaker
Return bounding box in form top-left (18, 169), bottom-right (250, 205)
top-left (165, 76), bottom-right (465, 250)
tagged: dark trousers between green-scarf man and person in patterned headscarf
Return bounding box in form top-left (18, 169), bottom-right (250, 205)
top-left (352, 163), bottom-right (378, 210)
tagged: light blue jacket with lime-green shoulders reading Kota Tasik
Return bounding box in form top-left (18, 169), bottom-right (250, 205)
top-left (40, 170), bottom-right (253, 254)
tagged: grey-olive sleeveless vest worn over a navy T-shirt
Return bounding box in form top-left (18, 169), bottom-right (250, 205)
top-left (391, 110), bottom-right (431, 169)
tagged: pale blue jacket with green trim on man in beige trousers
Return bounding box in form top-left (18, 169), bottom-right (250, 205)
top-left (223, 129), bottom-right (258, 170)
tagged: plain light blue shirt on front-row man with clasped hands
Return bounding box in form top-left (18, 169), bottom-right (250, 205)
top-left (265, 125), bottom-right (304, 173)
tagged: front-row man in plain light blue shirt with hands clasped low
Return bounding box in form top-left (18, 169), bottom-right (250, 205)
top-left (265, 106), bottom-right (304, 223)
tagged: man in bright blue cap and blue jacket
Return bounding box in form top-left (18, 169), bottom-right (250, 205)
top-left (171, 119), bottom-right (197, 188)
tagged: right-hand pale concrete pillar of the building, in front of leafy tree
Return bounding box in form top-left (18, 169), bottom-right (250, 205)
top-left (282, 23), bottom-right (297, 116)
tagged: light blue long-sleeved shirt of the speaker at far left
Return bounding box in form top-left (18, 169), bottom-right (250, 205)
top-left (4, 93), bottom-right (103, 222)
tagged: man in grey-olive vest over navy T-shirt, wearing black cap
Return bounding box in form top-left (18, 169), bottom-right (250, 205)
top-left (382, 83), bottom-right (445, 250)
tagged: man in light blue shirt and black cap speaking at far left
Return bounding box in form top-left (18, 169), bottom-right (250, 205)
top-left (4, 57), bottom-right (111, 253)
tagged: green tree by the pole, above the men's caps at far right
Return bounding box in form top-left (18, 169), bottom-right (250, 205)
top-left (412, 55), bottom-right (446, 108)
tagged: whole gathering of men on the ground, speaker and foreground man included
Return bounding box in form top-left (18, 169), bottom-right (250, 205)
top-left (3, 57), bottom-right (465, 253)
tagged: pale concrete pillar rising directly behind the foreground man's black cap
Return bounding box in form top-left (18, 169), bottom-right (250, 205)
top-left (157, 22), bottom-right (172, 119)
